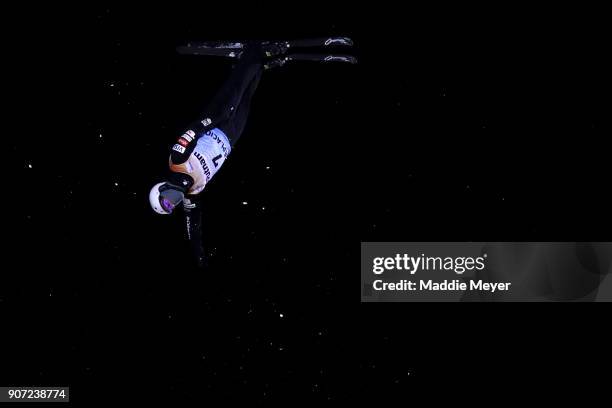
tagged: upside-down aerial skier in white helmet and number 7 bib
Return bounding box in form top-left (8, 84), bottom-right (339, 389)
top-left (149, 37), bottom-right (356, 266)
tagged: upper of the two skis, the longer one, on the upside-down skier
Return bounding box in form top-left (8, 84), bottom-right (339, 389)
top-left (176, 37), bottom-right (353, 58)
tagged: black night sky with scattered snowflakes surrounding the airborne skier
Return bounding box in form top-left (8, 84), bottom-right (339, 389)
top-left (0, 3), bottom-right (612, 404)
